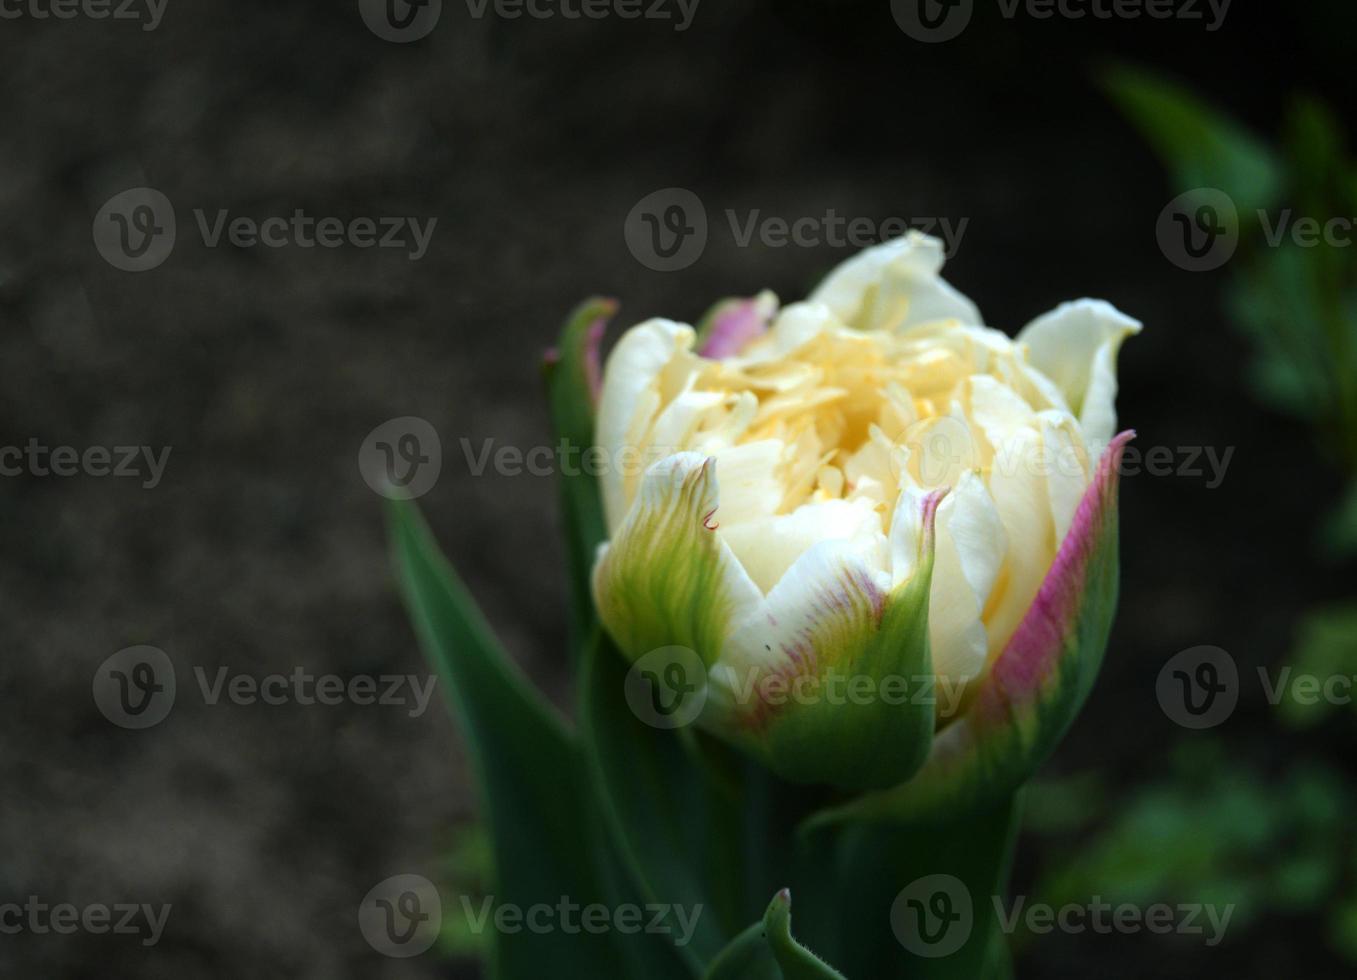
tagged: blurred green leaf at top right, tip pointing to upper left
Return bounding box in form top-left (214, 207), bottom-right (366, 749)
top-left (1102, 67), bottom-right (1281, 219)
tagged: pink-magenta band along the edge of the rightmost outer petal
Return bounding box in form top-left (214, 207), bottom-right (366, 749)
top-left (976, 430), bottom-right (1136, 718)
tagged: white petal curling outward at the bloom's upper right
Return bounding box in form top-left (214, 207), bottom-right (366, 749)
top-left (1016, 300), bottom-right (1141, 449)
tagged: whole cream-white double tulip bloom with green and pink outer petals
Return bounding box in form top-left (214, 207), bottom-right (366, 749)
top-left (593, 233), bottom-right (1140, 792)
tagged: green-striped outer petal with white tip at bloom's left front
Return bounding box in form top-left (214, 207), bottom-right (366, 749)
top-left (593, 452), bottom-right (763, 666)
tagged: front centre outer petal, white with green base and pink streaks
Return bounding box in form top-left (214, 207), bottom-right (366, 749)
top-left (711, 493), bottom-right (942, 790)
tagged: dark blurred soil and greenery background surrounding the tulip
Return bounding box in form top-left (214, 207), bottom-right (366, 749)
top-left (0, 0), bottom-right (1357, 979)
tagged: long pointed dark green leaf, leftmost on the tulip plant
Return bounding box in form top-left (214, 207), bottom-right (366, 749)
top-left (389, 501), bottom-right (622, 980)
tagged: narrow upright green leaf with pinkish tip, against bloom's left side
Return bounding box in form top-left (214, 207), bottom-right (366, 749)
top-left (544, 297), bottom-right (617, 654)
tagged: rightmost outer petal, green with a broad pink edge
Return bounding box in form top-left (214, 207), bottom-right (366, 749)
top-left (814, 432), bottom-right (1133, 823)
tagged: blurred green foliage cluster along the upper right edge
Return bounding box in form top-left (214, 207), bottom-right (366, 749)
top-left (1105, 68), bottom-right (1357, 537)
